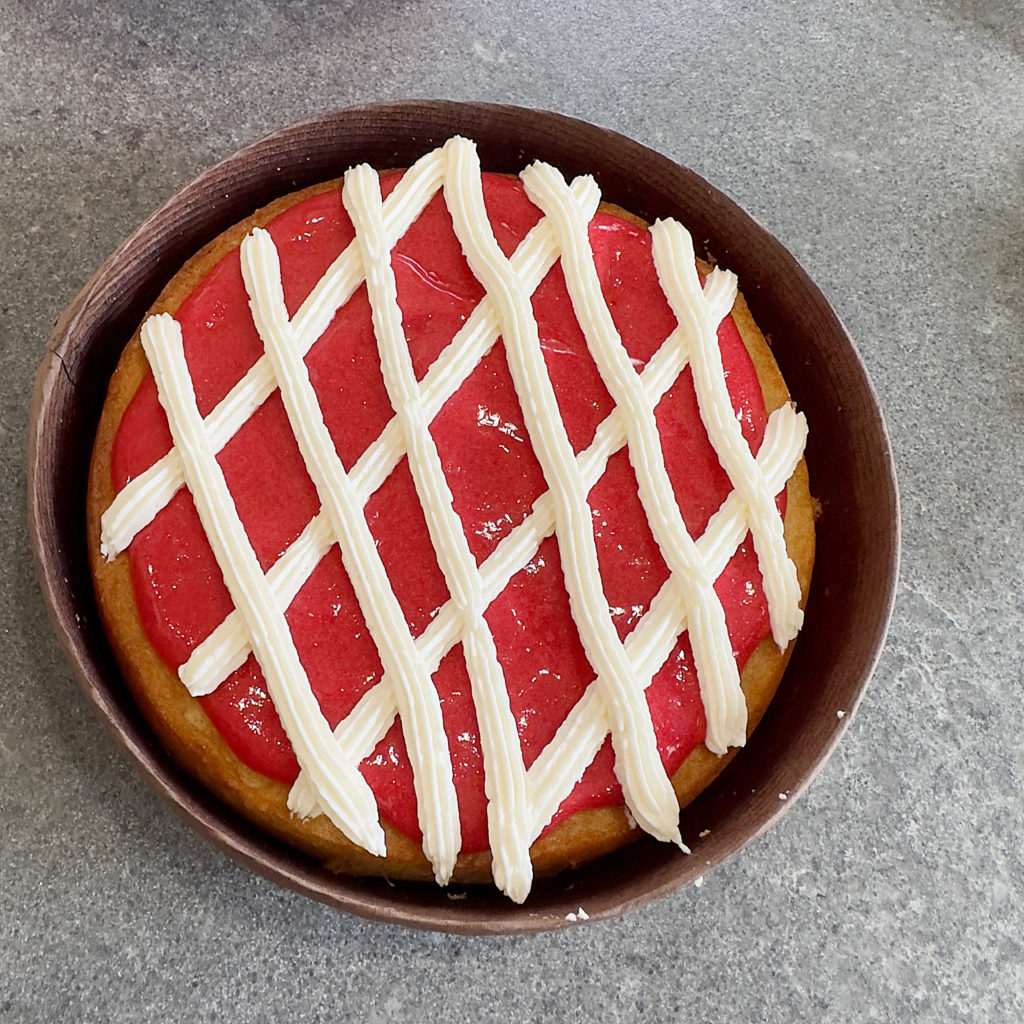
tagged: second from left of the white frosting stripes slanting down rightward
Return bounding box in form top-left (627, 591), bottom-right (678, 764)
top-left (242, 228), bottom-right (462, 885)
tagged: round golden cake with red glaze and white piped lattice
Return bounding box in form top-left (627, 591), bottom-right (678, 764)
top-left (88, 138), bottom-right (814, 901)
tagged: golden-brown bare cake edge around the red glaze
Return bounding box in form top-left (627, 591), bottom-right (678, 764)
top-left (87, 172), bottom-right (814, 883)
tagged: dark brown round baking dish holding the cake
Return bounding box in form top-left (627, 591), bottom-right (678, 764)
top-left (29, 101), bottom-right (899, 934)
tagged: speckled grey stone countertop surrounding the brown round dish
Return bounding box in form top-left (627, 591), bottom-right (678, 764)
top-left (0, 0), bottom-right (1024, 1024)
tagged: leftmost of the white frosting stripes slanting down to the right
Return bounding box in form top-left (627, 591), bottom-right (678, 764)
top-left (142, 314), bottom-right (385, 855)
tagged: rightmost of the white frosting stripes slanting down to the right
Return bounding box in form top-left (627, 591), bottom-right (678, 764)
top-left (651, 220), bottom-right (804, 649)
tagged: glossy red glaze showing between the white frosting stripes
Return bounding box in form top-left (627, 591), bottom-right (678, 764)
top-left (113, 175), bottom-right (768, 852)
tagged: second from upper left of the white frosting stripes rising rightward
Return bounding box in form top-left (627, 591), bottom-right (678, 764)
top-left (180, 178), bottom-right (602, 696)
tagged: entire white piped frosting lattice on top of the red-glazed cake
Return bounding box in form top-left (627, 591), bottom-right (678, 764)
top-left (101, 138), bottom-right (806, 901)
